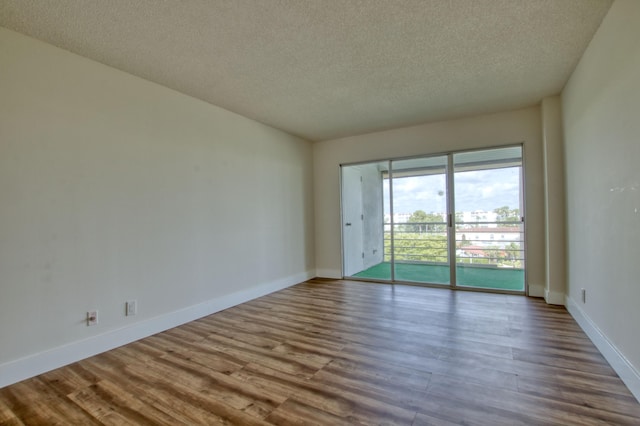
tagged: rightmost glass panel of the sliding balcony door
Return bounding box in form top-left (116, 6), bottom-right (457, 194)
top-left (453, 146), bottom-right (525, 291)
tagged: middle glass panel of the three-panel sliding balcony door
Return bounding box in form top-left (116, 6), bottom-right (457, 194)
top-left (387, 156), bottom-right (451, 284)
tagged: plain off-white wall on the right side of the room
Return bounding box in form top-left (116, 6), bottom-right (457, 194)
top-left (562, 0), bottom-right (640, 399)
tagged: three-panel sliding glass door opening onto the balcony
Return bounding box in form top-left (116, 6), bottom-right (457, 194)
top-left (341, 146), bottom-right (525, 292)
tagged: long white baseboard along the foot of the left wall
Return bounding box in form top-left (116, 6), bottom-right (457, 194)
top-left (0, 271), bottom-right (315, 388)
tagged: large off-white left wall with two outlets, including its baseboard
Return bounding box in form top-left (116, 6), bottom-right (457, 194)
top-left (0, 28), bottom-right (315, 386)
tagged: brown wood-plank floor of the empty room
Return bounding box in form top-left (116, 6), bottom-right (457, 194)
top-left (0, 280), bottom-right (640, 426)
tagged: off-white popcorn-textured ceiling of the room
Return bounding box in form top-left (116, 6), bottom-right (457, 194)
top-left (0, 0), bottom-right (611, 140)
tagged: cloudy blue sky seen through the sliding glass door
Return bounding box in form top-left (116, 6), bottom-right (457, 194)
top-left (384, 167), bottom-right (520, 213)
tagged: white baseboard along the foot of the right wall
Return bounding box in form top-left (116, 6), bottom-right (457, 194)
top-left (565, 296), bottom-right (640, 402)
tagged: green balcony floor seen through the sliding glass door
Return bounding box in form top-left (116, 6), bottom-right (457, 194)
top-left (353, 262), bottom-right (524, 291)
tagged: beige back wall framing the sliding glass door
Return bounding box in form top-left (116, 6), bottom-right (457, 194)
top-left (313, 107), bottom-right (545, 296)
